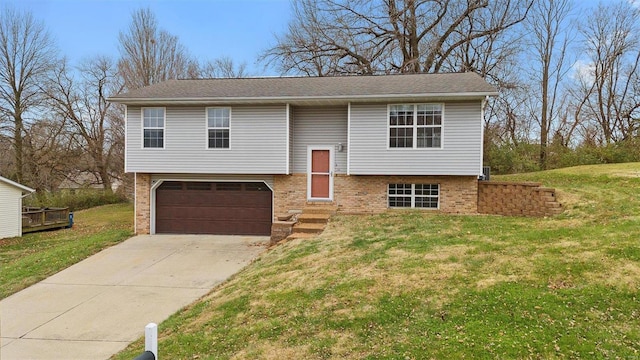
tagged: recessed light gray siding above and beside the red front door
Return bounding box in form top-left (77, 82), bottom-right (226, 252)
top-left (293, 106), bottom-right (348, 174)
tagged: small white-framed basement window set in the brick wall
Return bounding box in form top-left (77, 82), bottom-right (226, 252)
top-left (387, 184), bottom-right (440, 209)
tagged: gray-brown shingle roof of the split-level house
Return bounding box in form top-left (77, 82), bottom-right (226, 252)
top-left (110, 73), bottom-right (496, 103)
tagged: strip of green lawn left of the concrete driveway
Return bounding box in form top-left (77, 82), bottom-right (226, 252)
top-left (0, 204), bottom-right (133, 299)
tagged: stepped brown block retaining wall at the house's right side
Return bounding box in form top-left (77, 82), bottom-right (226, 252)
top-left (478, 181), bottom-right (562, 216)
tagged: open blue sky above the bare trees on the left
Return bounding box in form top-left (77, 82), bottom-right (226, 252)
top-left (0, 0), bottom-right (290, 76)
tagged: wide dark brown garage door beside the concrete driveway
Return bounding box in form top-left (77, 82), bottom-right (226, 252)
top-left (156, 181), bottom-right (272, 235)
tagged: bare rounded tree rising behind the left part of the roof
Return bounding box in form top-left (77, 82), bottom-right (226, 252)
top-left (118, 8), bottom-right (198, 89)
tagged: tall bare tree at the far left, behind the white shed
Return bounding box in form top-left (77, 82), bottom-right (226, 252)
top-left (0, 7), bottom-right (57, 182)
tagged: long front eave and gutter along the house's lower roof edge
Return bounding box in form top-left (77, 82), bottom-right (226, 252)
top-left (107, 91), bottom-right (498, 105)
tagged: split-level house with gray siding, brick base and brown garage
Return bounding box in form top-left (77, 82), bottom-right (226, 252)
top-left (110, 73), bottom-right (497, 235)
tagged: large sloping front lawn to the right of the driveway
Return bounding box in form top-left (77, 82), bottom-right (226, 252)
top-left (116, 163), bottom-right (640, 359)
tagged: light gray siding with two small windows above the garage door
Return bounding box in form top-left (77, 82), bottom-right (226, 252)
top-left (126, 105), bottom-right (288, 174)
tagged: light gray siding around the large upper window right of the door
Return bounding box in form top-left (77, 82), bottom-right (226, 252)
top-left (349, 100), bottom-right (482, 175)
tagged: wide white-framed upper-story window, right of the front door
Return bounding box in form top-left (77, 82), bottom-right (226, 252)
top-left (389, 104), bottom-right (443, 149)
